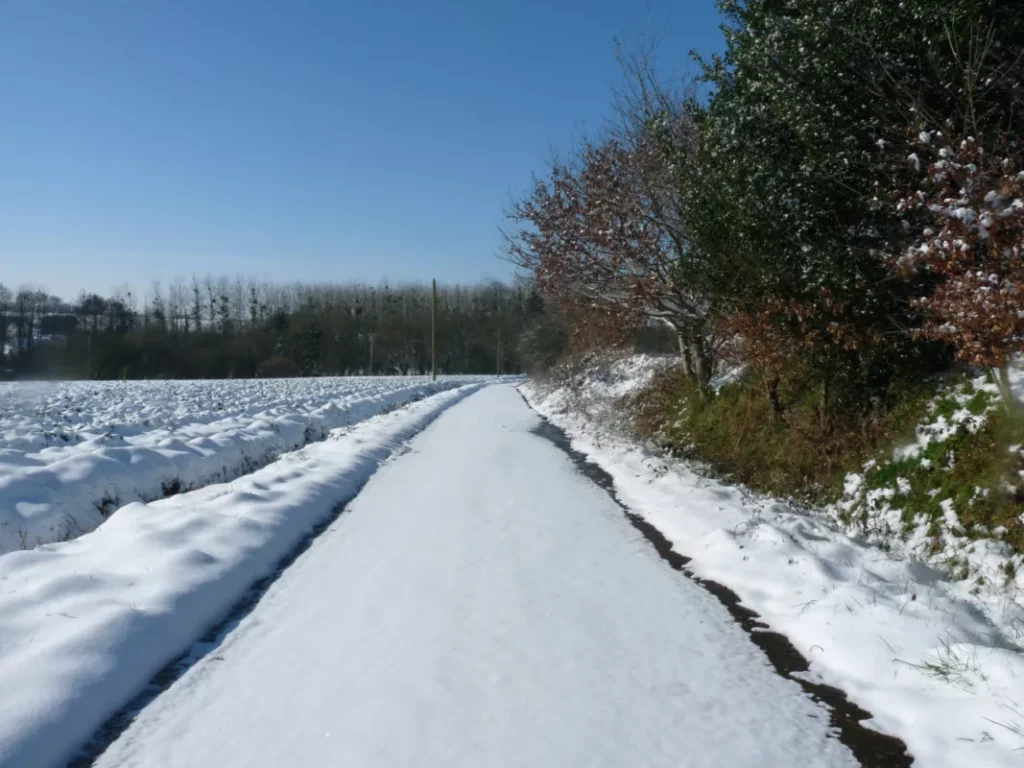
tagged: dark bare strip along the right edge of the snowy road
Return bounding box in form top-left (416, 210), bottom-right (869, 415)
top-left (524, 398), bottom-right (913, 768)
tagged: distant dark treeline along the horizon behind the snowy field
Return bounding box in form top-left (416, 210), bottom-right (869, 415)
top-left (0, 278), bottom-right (544, 379)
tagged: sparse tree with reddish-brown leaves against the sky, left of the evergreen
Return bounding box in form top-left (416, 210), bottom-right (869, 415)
top-left (506, 116), bottom-right (714, 384)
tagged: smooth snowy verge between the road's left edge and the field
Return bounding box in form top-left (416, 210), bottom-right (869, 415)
top-left (0, 384), bottom-right (482, 768)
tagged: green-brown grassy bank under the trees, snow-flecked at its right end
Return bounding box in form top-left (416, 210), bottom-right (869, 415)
top-left (630, 371), bottom-right (1024, 578)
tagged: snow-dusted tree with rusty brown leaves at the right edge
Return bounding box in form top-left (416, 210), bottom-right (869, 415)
top-left (893, 131), bottom-right (1024, 406)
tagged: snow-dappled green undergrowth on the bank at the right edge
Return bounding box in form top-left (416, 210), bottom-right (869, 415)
top-left (828, 376), bottom-right (1024, 579)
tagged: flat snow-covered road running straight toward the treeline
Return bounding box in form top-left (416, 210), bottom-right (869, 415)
top-left (90, 385), bottom-right (857, 768)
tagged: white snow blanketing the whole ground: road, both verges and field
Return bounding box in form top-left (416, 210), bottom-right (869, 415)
top-left (0, 368), bottom-right (1024, 768)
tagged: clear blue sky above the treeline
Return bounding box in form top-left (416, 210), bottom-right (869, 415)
top-left (0, 0), bottom-right (721, 298)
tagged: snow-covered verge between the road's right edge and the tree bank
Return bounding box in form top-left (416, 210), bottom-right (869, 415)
top-left (520, 378), bottom-right (1024, 768)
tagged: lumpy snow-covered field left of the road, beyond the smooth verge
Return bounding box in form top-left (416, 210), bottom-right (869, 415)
top-left (0, 377), bottom-right (484, 554)
